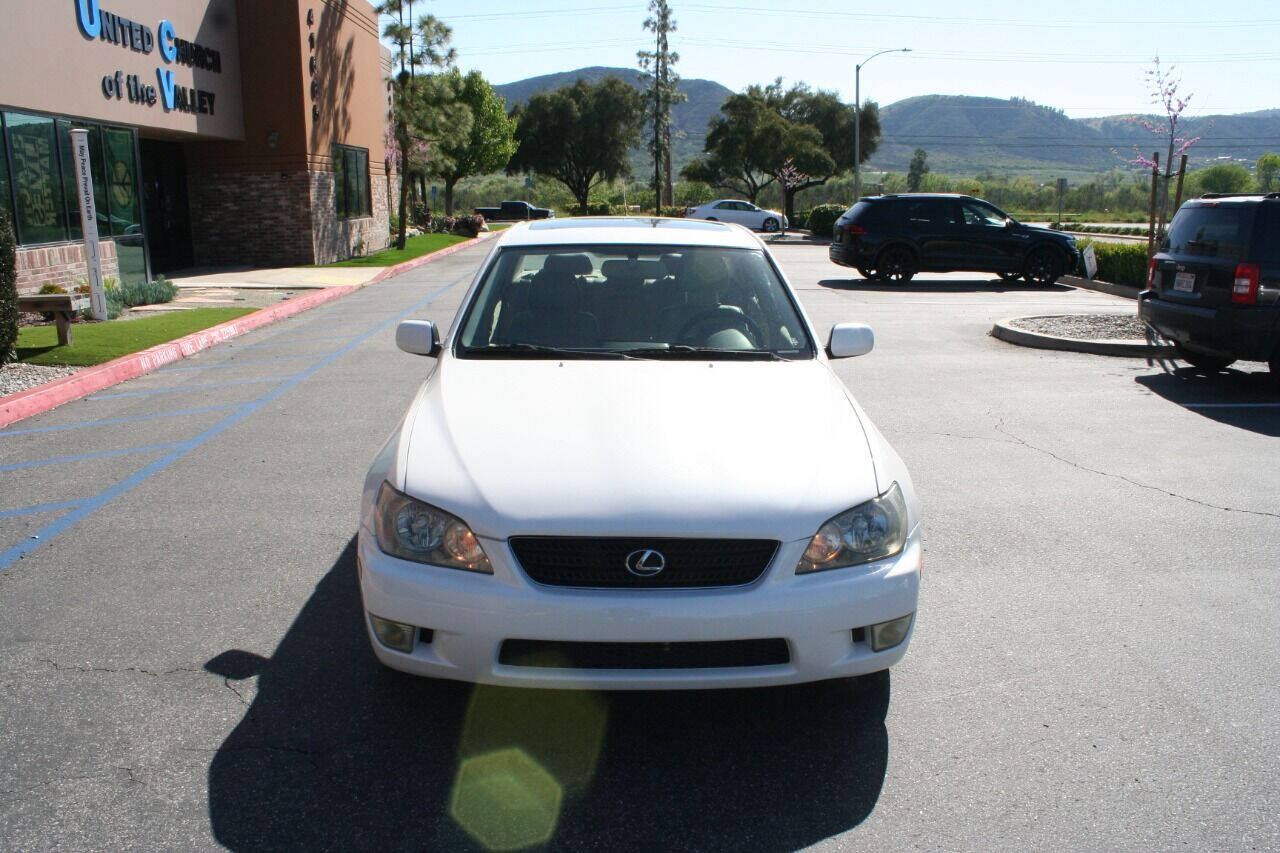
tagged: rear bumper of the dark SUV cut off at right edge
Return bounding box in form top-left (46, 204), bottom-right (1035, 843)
top-left (1138, 291), bottom-right (1280, 361)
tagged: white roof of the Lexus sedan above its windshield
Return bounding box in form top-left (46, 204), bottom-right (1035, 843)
top-left (499, 216), bottom-right (762, 248)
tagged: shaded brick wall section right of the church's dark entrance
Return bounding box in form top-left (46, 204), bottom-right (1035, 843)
top-left (187, 170), bottom-right (316, 266)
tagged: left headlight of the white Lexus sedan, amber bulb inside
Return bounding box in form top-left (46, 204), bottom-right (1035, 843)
top-left (374, 483), bottom-right (493, 575)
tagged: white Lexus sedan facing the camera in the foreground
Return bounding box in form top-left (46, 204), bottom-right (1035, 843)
top-left (358, 218), bottom-right (923, 689)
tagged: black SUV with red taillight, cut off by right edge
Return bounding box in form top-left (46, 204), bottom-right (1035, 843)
top-left (1138, 192), bottom-right (1280, 377)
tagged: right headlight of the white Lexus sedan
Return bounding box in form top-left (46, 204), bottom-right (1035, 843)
top-left (796, 483), bottom-right (906, 575)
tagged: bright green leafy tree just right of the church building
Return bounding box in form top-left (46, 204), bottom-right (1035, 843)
top-left (428, 69), bottom-right (516, 216)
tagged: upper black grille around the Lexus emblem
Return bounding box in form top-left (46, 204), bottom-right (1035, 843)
top-left (511, 537), bottom-right (778, 588)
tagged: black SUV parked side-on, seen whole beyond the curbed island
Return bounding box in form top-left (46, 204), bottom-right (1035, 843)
top-left (828, 193), bottom-right (1079, 284)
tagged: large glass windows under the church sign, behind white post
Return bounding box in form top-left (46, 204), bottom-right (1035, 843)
top-left (0, 113), bottom-right (142, 247)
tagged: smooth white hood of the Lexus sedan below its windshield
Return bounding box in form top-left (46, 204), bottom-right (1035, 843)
top-left (394, 356), bottom-right (877, 540)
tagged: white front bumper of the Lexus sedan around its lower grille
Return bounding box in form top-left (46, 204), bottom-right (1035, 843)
top-left (357, 528), bottom-right (922, 689)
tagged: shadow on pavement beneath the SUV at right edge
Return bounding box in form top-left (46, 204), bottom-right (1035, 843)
top-left (1134, 362), bottom-right (1280, 437)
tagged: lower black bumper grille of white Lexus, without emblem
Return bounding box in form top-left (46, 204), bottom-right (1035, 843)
top-left (498, 639), bottom-right (791, 670)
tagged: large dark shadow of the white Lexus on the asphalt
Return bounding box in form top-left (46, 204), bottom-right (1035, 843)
top-left (206, 539), bottom-right (890, 850)
